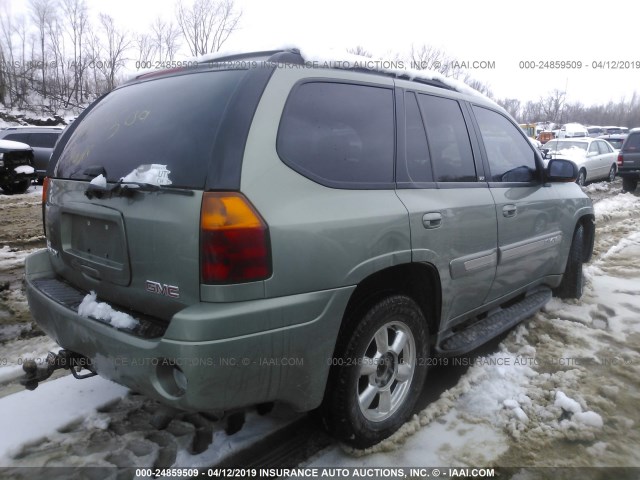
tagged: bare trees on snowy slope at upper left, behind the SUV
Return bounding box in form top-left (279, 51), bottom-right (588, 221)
top-left (0, 0), bottom-right (242, 113)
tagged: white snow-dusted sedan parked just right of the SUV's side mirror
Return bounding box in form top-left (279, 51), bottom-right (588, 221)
top-left (542, 137), bottom-right (618, 186)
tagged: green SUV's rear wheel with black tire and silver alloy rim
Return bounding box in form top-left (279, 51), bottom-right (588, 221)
top-left (322, 295), bottom-right (429, 448)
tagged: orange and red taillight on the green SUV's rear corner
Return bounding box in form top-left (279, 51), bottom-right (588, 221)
top-left (200, 192), bottom-right (271, 283)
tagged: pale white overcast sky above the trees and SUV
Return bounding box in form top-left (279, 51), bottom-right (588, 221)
top-left (6, 0), bottom-right (640, 105)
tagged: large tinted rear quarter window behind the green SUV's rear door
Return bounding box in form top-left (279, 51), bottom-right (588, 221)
top-left (277, 82), bottom-right (395, 188)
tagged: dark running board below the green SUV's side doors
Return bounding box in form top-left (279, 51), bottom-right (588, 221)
top-left (436, 288), bottom-right (552, 357)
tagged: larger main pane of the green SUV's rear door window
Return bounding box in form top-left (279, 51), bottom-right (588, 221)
top-left (418, 94), bottom-right (477, 182)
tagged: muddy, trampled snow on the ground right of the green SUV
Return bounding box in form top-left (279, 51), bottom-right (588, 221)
top-left (309, 186), bottom-right (640, 468)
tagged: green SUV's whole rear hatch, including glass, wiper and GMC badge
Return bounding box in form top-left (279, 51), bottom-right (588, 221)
top-left (45, 69), bottom-right (246, 320)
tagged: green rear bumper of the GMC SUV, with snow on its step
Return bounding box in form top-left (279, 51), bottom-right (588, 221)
top-left (25, 251), bottom-right (354, 411)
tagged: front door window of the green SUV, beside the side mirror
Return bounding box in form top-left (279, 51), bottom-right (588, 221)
top-left (473, 106), bottom-right (536, 182)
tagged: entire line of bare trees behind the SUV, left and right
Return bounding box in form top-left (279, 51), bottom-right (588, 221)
top-left (0, 4), bottom-right (640, 127)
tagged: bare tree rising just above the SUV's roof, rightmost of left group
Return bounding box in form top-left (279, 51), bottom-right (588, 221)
top-left (177, 0), bottom-right (242, 56)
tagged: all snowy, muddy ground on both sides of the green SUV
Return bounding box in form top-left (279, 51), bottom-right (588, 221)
top-left (0, 181), bottom-right (640, 472)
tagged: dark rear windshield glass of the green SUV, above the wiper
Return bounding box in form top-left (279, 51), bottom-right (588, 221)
top-left (55, 70), bottom-right (246, 189)
